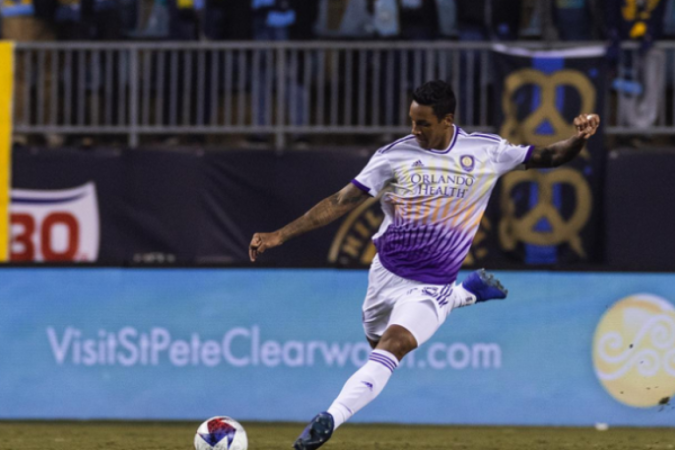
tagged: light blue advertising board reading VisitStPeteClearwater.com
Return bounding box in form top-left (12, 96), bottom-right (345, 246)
top-left (0, 269), bottom-right (675, 426)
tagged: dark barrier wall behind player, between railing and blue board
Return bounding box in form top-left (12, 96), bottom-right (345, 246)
top-left (11, 149), bottom-right (675, 270)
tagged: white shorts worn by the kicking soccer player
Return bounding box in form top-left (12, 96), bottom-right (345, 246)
top-left (363, 255), bottom-right (459, 347)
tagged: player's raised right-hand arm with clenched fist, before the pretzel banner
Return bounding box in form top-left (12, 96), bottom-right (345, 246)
top-left (526, 114), bottom-right (600, 169)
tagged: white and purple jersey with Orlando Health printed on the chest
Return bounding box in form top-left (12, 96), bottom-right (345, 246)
top-left (352, 125), bottom-right (533, 284)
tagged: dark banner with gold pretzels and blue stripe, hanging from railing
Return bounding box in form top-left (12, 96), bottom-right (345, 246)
top-left (493, 46), bottom-right (606, 264)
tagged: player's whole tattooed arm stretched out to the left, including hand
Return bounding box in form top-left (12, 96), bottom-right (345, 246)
top-left (248, 183), bottom-right (369, 261)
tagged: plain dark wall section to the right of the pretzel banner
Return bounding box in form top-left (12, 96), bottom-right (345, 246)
top-left (605, 148), bottom-right (675, 270)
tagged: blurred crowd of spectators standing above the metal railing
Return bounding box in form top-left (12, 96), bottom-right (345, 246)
top-left (0, 0), bottom-right (675, 43)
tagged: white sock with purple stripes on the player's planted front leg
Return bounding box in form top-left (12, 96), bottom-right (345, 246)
top-left (328, 350), bottom-right (398, 430)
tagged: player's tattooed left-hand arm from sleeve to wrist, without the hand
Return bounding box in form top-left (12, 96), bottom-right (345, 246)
top-left (279, 183), bottom-right (368, 242)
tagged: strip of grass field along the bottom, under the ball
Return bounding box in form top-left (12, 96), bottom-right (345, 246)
top-left (0, 421), bottom-right (675, 450)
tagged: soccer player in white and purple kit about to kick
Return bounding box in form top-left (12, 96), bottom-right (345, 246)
top-left (249, 81), bottom-right (600, 450)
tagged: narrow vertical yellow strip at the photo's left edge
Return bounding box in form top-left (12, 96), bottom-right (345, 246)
top-left (0, 42), bottom-right (14, 262)
